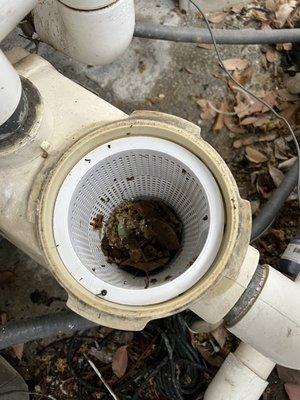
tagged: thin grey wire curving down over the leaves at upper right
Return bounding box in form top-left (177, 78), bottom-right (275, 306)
top-left (189, 0), bottom-right (300, 203)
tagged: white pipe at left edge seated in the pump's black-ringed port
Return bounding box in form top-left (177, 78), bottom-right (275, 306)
top-left (0, 50), bottom-right (22, 126)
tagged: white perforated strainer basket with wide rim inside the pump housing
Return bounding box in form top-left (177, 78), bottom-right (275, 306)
top-left (53, 136), bottom-right (224, 306)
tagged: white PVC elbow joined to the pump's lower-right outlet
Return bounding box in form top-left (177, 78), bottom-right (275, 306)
top-left (229, 267), bottom-right (300, 369)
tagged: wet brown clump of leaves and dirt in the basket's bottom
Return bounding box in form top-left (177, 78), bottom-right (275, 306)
top-left (101, 200), bottom-right (182, 275)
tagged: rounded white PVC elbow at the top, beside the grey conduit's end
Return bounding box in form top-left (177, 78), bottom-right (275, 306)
top-left (34, 0), bottom-right (135, 65)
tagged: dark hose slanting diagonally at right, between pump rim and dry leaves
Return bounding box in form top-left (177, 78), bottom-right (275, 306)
top-left (251, 162), bottom-right (298, 243)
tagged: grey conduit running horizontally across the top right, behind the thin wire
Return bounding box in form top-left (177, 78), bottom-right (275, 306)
top-left (134, 22), bottom-right (300, 44)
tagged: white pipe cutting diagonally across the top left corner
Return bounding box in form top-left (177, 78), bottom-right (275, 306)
top-left (0, 0), bottom-right (37, 41)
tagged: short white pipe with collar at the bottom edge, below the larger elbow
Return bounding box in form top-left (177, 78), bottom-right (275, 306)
top-left (204, 343), bottom-right (275, 400)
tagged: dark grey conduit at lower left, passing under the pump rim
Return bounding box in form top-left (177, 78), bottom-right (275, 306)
top-left (0, 311), bottom-right (98, 350)
